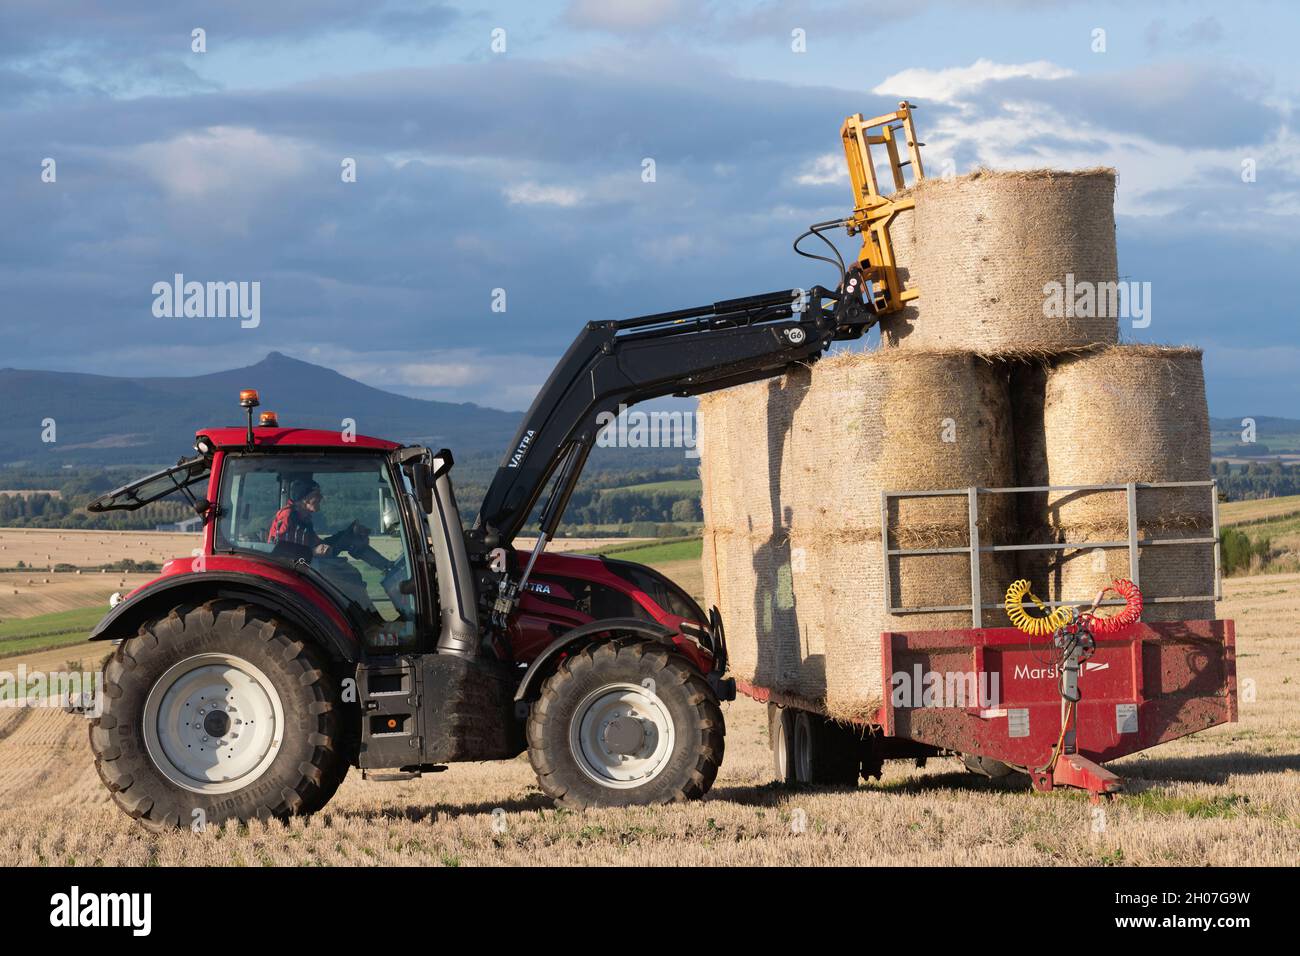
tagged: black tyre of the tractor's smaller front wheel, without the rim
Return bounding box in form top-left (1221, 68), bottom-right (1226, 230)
top-left (527, 639), bottom-right (725, 809)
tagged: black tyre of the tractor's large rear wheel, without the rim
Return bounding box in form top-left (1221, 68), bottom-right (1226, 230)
top-left (90, 600), bottom-right (348, 832)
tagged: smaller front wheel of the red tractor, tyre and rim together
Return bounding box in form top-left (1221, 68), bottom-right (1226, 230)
top-left (528, 639), bottom-right (725, 808)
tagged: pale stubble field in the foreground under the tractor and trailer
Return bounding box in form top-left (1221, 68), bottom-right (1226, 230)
top-left (0, 561), bottom-right (1300, 866)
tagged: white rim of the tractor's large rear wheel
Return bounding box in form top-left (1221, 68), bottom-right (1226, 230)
top-left (144, 654), bottom-right (285, 793)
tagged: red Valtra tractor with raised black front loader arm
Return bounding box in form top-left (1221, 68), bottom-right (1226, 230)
top-left (91, 281), bottom-right (875, 830)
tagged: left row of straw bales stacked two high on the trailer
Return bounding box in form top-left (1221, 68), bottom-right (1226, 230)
top-left (699, 350), bottom-right (1014, 718)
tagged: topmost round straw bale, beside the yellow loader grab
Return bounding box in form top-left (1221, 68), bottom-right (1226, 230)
top-left (883, 169), bottom-right (1119, 355)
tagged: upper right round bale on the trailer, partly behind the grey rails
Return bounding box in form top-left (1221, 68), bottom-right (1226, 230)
top-left (1043, 345), bottom-right (1213, 540)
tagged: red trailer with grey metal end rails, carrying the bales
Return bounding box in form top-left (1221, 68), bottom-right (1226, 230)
top-left (737, 481), bottom-right (1236, 800)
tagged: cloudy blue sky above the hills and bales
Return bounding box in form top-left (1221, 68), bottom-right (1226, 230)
top-left (0, 0), bottom-right (1300, 418)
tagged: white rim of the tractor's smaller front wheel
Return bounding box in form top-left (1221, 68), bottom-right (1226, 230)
top-left (569, 684), bottom-right (676, 790)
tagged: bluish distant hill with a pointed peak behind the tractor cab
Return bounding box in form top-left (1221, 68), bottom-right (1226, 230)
top-left (0, 352), bottom-right (520, 466)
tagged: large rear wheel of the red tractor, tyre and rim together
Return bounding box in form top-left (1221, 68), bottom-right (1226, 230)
top-left (90, 601), bottom-right (347, 832)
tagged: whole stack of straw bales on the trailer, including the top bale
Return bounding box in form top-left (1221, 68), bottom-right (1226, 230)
top-left (699, 169), bottom-right (1213, 718)
